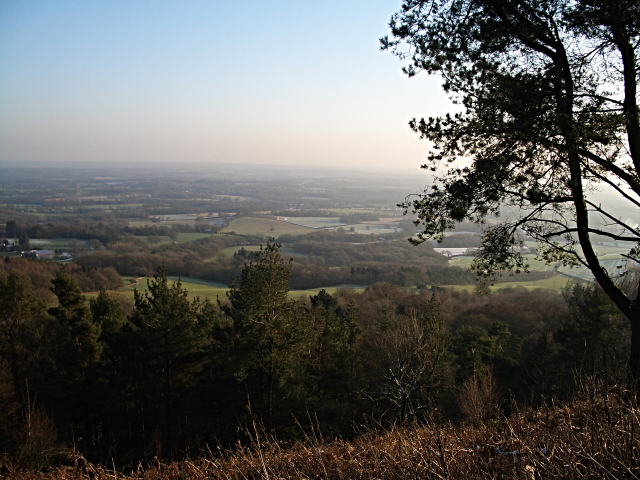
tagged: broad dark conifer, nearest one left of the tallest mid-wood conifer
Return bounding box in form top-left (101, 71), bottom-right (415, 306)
top-left (130, 265), bottom-right (213, 452)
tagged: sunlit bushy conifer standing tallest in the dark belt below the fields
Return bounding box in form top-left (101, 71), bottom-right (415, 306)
top-left (226, 241), bottom-right (308, 433)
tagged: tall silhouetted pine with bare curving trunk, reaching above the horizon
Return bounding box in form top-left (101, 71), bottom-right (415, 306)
top-left (381, 0), bottom-right (640, 389)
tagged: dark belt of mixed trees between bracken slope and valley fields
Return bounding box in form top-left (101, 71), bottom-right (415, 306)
top-left (0, 243), bottom-right (635, 474)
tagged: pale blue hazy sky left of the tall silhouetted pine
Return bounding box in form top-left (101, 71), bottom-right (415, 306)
top-left (0, 0), bottom-right (451, 171)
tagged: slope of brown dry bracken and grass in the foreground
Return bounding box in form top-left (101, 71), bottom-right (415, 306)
top-left (6, 392), bottom-right (640, 480)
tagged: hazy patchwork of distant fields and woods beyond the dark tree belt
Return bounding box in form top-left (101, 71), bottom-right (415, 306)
top-left (0, 163), bottom-right (624, 298)
